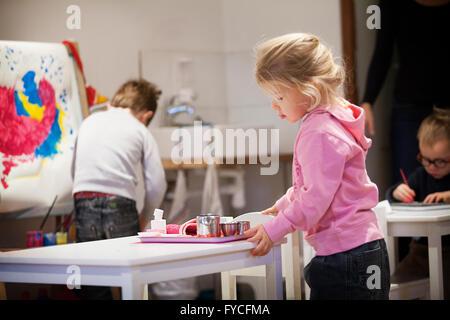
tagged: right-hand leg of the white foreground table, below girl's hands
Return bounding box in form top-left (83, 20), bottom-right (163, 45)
top-left (266, 245), bottom-right (283, 300)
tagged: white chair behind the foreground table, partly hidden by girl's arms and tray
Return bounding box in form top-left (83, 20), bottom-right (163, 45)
top-left (221, 212), bottom-right (301, 300)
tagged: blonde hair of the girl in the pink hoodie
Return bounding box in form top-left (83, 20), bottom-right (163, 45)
top-left (255, 33), bottom-right (345, 111)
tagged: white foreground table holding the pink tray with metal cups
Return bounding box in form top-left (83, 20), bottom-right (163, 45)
top-left (0, 236), bottom-right (283, 300)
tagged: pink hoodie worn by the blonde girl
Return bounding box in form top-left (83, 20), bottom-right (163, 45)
top-left (263, 105), bottom-right (383, 256)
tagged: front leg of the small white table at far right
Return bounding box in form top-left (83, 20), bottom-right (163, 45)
top-left (428, 232), bottom-right (444, 300)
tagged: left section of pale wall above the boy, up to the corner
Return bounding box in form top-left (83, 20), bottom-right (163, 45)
top-left (0, 0), bottom-right (227, 124)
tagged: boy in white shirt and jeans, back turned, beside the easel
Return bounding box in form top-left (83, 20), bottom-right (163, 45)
top-left (72, 79), bottom-right (167, 299)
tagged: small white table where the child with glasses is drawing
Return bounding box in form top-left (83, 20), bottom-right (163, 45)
top-left (386, 206), bottom-right (450, 300)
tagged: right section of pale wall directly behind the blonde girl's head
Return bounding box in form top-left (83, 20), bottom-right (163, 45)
top-left (222, 0), bottom-right (342, 153)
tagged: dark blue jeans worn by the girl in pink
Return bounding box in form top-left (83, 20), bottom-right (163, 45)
top-left (305, 239), bottom-right (391, 300)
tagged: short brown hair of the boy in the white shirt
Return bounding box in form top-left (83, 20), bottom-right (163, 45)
top-left (111, 79), bottom-right (162, 114)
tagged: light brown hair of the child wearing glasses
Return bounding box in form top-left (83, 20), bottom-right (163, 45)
top-left (417, 107), bottom-right (450, 146)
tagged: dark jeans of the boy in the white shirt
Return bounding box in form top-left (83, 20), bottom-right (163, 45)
top-left (75, 196), bottom-right (139, 300)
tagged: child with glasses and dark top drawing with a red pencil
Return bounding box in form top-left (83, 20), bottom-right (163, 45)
top-left (386, 108), bottom-right (450, 299)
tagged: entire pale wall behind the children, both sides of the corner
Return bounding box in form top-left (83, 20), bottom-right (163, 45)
top-left (0, 0), bottom-right (342, 215)
